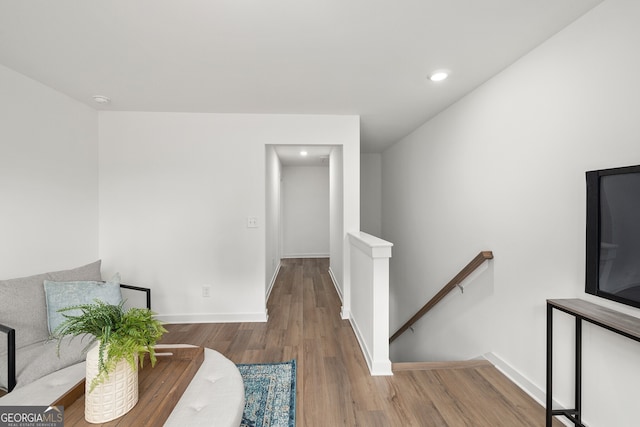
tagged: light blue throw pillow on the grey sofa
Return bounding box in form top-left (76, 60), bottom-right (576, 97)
top-left (44, 273), bottom-right (122, 333)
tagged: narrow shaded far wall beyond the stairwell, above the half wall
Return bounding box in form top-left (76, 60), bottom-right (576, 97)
top-left (360, 153), bottom-right (382, 237)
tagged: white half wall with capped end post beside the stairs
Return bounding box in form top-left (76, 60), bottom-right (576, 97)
top-left (349, 232), bottom-right (393, 375)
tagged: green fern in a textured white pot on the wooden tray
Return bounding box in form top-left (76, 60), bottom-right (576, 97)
top-left (52, 300), bottom-right (166, 422)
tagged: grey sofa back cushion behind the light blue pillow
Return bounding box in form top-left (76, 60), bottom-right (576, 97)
top-left (0, 260), bottom-right (102, 387)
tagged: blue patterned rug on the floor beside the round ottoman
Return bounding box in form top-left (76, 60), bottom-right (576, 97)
top-left (237, 359), bottom-right (296, 427)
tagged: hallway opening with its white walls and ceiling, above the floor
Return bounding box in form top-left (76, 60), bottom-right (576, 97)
top-left (265, 145), bottom-right (342, 302)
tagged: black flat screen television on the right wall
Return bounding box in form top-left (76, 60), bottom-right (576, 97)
top-left (585, 165), bottom-right (640, 308)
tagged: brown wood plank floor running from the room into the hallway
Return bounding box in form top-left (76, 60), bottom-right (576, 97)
top-left (163, 259), bottom-right (561, 427)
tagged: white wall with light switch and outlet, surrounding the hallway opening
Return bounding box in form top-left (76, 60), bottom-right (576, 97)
top-left (100, 112), bottom-right (359, 322)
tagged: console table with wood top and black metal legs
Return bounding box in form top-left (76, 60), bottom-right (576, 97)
top-left (546, 299), bottom-right (640, 427)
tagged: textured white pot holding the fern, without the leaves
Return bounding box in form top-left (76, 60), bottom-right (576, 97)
top-left (84, 345), bottom-right (138, 424)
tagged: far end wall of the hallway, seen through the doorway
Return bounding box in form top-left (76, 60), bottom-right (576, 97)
top-left (282, 166), bottom-right (329, 258)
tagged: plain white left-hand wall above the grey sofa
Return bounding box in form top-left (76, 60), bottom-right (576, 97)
top-left (0, 62), bottom-right (98, 278)
